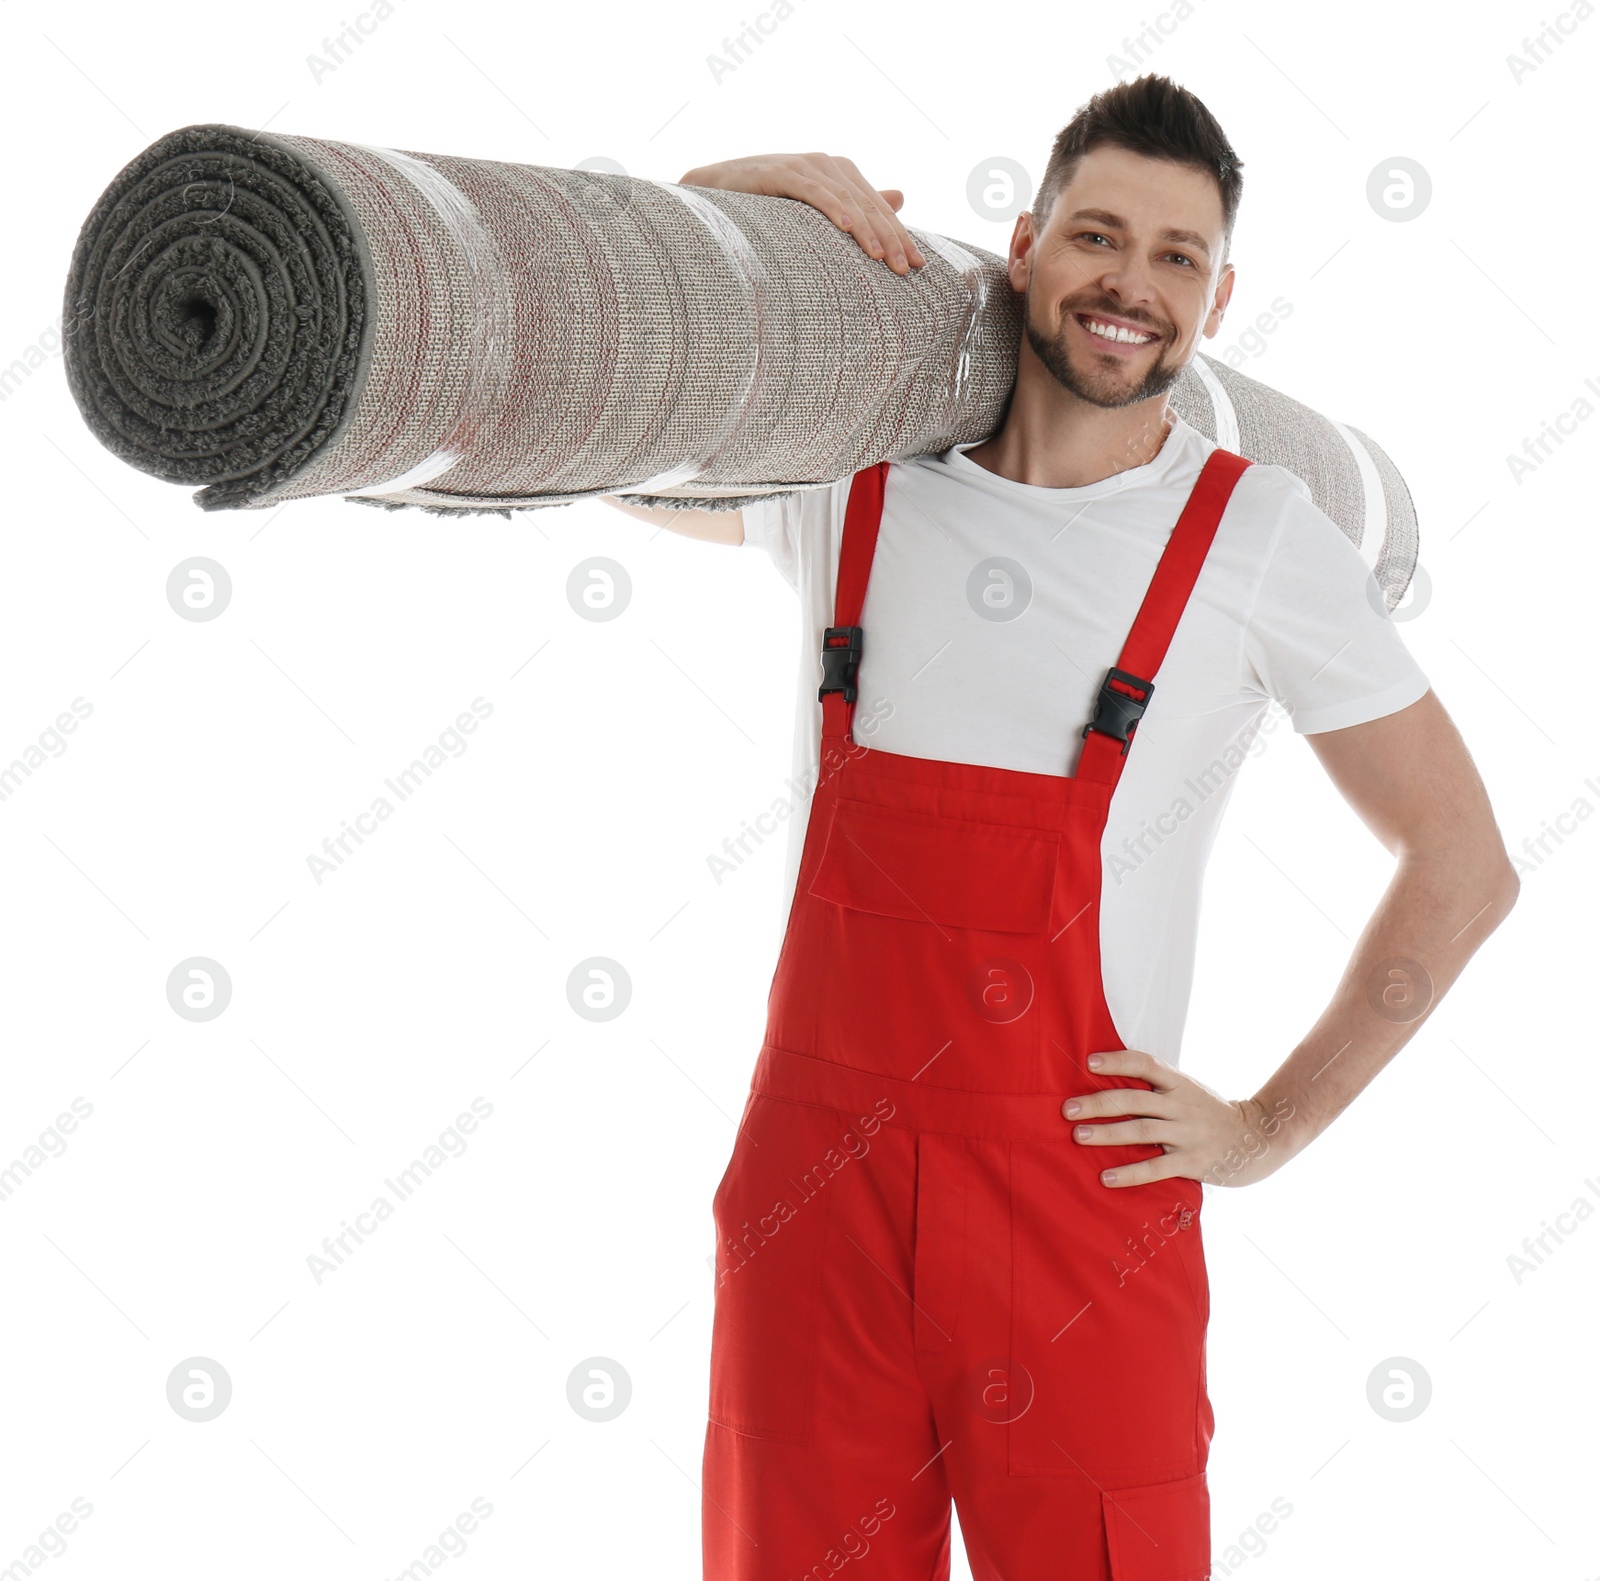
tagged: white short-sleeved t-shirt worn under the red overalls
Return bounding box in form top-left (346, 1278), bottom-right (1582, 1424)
top-left (732, 414), bottom-right (1427, 1064)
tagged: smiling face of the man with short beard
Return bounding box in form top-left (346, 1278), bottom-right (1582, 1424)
top-left (1010, 144), bottom-right (1234, 406)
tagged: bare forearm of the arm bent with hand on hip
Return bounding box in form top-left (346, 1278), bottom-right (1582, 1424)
top-left (1248, 834), bottom-right (1517, 1167)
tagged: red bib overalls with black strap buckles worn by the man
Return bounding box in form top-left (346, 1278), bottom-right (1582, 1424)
top-left (702, 450), bottom-right (1250, 1581)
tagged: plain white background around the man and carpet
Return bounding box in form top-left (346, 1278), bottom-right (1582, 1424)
top-left (0, 0), bottom-right (1600, 1581)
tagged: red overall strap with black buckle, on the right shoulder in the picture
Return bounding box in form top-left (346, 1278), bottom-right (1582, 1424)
top-left (1074, 448), bottom-right (1250, 787)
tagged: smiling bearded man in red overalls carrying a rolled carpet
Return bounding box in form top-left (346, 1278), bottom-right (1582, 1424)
top-left (601, 77), bottom-right (1517, 1581)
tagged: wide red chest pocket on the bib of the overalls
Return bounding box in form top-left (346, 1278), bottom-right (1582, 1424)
top-left (810, 799), bottom-right (1061, 933)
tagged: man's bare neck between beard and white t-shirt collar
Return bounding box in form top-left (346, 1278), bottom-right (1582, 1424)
top-left (963, 381), bottom-right (1176, 488)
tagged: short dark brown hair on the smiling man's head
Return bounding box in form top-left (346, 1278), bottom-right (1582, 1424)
top-left (1034, 72), bottom-right (1245, 258)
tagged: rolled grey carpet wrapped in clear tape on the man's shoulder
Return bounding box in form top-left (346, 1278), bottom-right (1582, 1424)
top-left (62, 125), bottom-right (1416, 606)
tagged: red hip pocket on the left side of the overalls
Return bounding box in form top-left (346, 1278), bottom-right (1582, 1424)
top-left (710, 1093), bottom-right (829, 1443)
